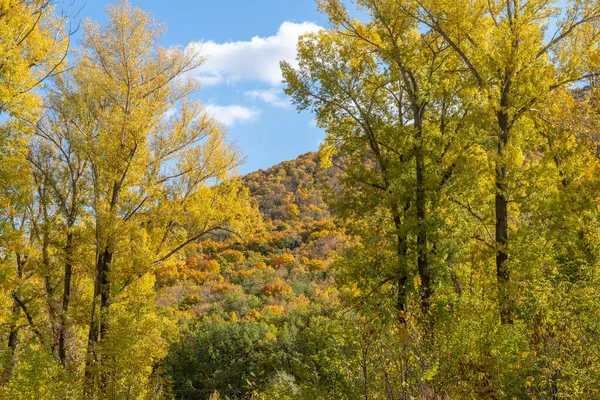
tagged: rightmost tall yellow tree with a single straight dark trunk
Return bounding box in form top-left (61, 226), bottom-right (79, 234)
top-left (402, 0), bottom-right (600, 324)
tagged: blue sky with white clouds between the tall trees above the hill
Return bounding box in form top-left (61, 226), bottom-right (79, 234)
top-left (74, 0), bottom-right (327, 174)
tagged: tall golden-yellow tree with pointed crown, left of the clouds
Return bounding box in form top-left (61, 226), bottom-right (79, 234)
top-left (59, 2), bottom-right (255, 397)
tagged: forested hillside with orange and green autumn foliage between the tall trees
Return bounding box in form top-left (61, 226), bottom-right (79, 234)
top-left (158, 153), bottom-right (351, 399)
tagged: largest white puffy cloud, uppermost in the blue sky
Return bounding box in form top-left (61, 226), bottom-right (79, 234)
top-left (188, 21), bottom-right (322, 86)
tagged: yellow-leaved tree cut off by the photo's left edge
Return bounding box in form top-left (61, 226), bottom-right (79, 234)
top-left (0, 0), bottom-right (71, 385)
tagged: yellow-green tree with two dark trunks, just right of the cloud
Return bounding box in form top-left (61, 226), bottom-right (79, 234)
top-left (282, 1), bottom-right (469, 313)
